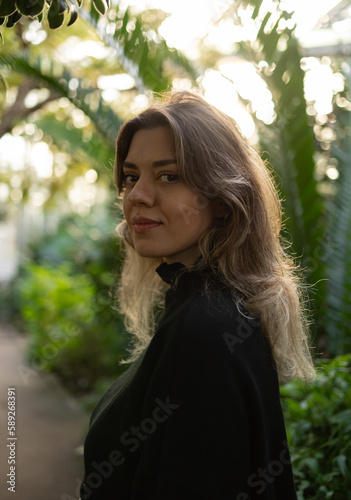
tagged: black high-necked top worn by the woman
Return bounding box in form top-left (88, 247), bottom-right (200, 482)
top-left (81, 263), bottom-right (296, 500)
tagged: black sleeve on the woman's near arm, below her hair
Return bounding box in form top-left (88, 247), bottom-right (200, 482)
top-left (147, 301), bottom-right (296, 500)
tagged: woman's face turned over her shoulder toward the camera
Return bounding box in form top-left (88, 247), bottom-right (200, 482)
top-left (123, 126), bottom-right (219, 265)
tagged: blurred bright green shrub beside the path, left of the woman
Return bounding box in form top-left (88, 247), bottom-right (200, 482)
top-left (19, 263), bottom-right (125, 392)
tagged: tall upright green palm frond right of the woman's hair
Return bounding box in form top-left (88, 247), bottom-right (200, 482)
top-left (212, 0), bottom-right (351, 355)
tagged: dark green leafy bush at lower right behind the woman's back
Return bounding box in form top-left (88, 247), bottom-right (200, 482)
top-left (281, 354), bottom-right (351, 500)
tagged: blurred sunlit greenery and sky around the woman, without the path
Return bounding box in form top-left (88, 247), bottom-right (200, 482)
top-left (0, 0), bottom-right (351, 500)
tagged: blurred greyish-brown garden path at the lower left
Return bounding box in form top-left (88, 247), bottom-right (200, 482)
top-left (0, 325), bottom-right (88, 500)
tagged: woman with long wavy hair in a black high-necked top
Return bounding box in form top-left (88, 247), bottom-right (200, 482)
top-left (81, 92), bottom-right (314, 500)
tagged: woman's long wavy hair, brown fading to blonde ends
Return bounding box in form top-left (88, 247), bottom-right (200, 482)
top-left (115, 92), bottom-right (314, 382)
